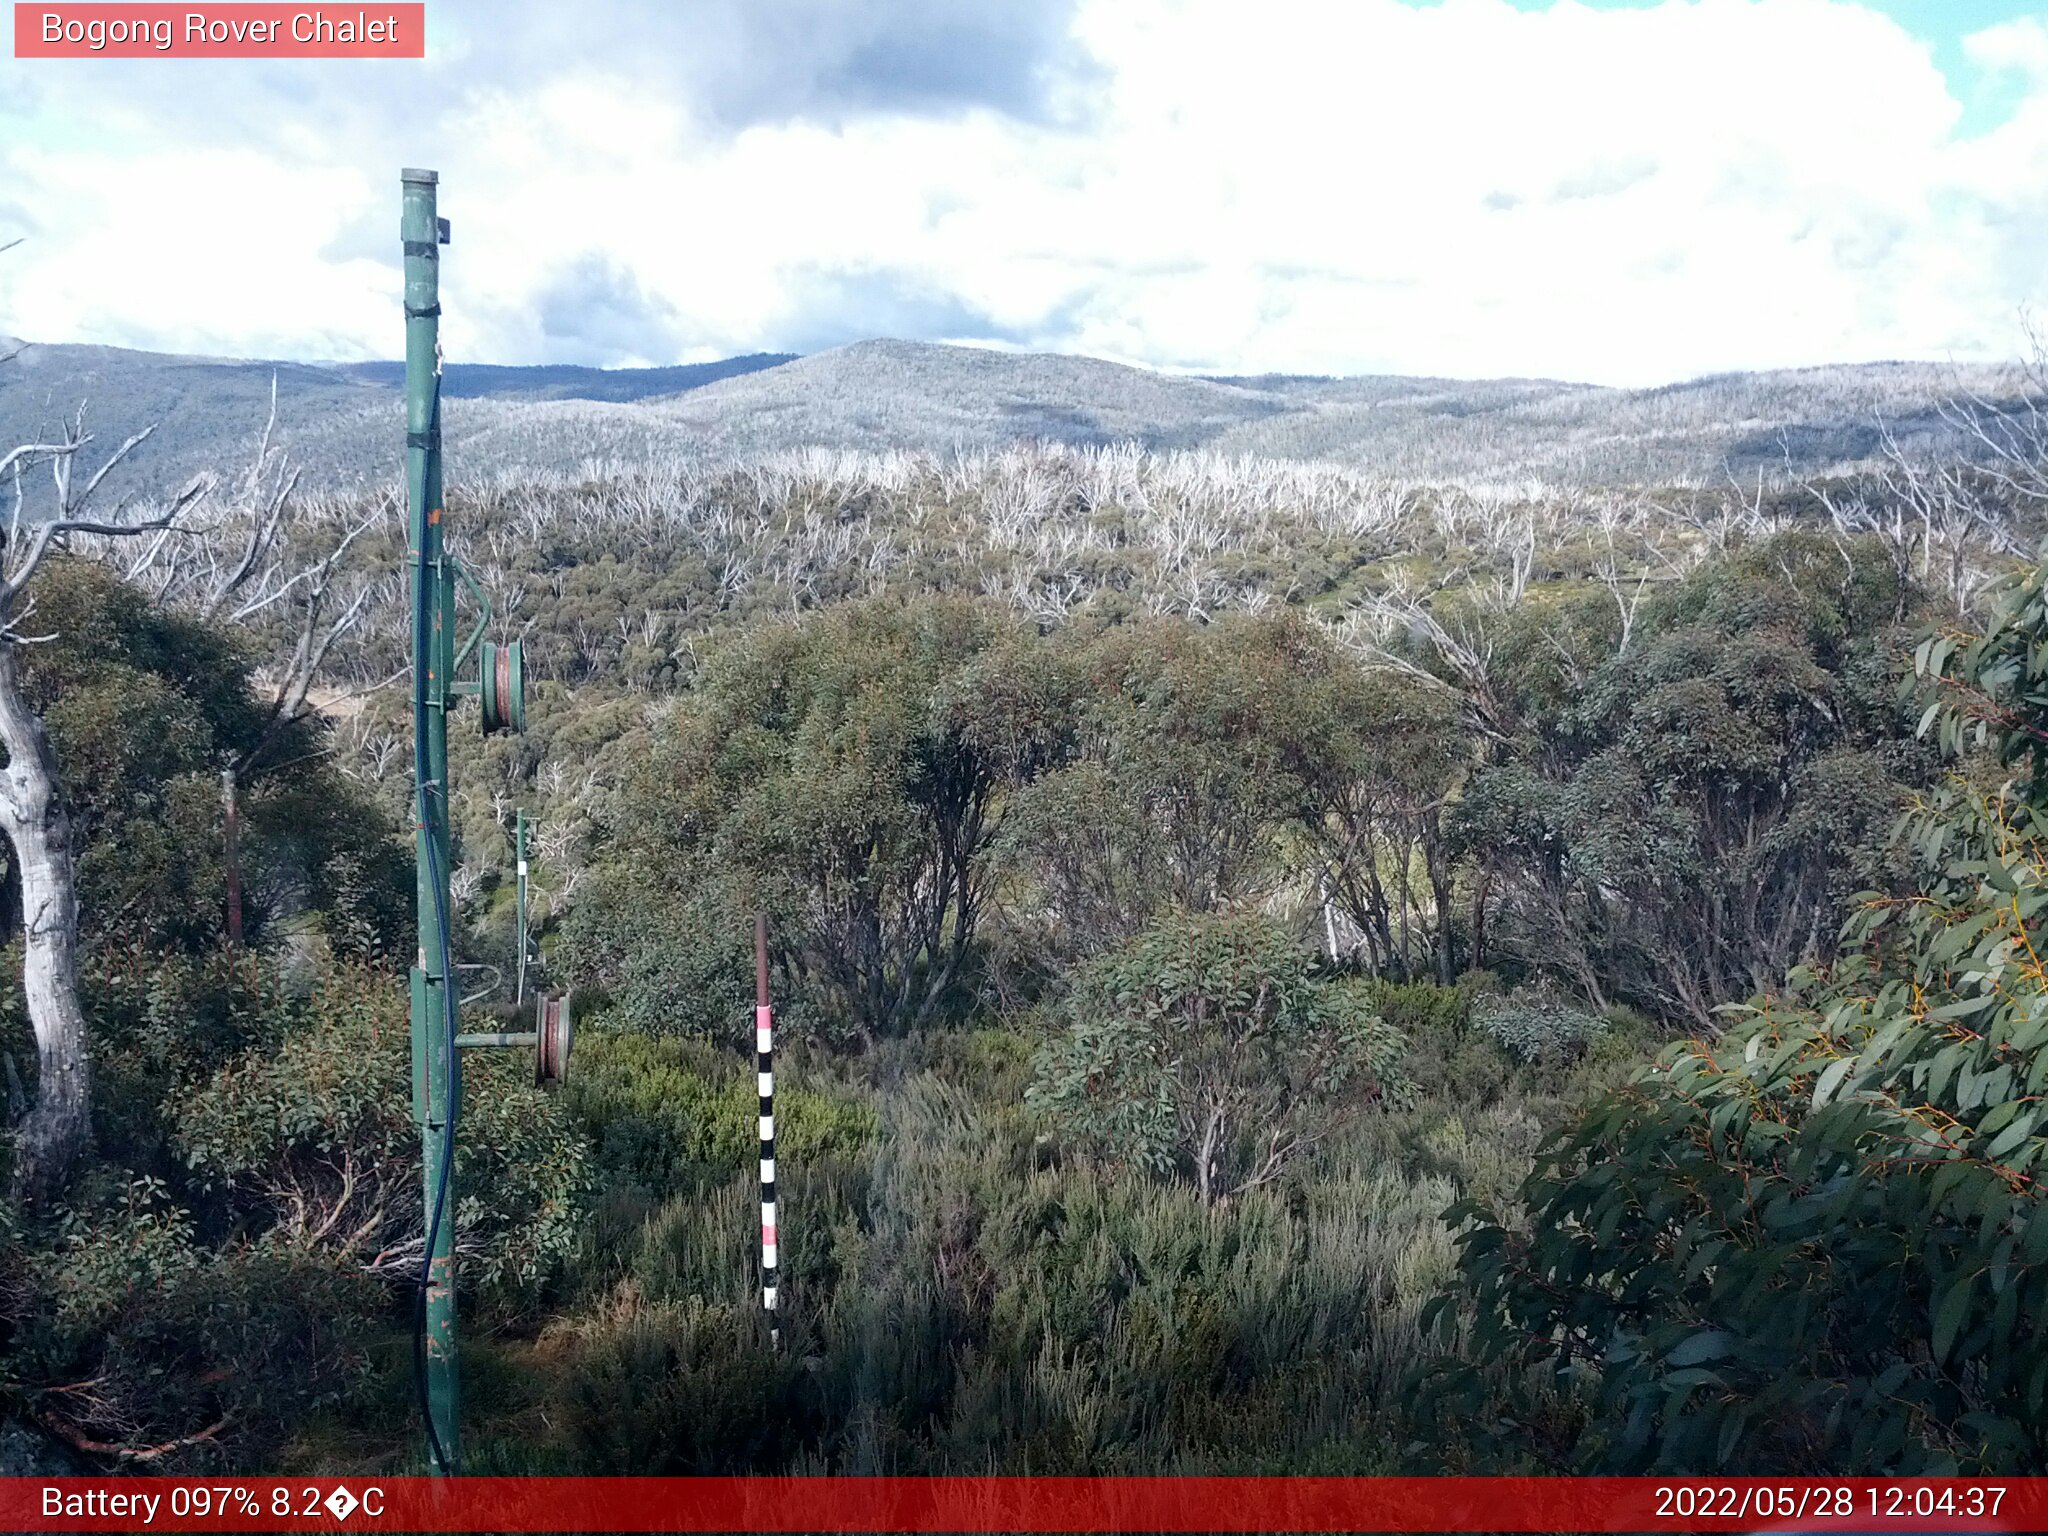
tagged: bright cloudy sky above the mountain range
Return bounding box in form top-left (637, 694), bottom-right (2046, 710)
top-left (0, 0), bottom-right (2048, 385)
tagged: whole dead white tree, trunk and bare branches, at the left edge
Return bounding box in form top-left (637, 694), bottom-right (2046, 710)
top-left (0, 408), bottom-right (205, 1202)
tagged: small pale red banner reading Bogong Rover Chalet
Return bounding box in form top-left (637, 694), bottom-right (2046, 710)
top-left (14, 0), bottom-right (426, 59)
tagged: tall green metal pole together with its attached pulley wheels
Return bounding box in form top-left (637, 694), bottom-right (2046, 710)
top-left (399, 170), bottom-right (569, 1475)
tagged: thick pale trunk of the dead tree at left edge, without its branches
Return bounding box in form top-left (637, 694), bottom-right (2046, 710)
top-left (0, 641), bottom-right (92, 1202)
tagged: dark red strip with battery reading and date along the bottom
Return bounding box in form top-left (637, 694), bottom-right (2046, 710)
top-left (0, 1477), bottom-right (2048, 1532)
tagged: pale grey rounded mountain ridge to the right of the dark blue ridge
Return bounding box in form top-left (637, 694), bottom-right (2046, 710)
top-left (630, 342), bottom-right (2007, 483)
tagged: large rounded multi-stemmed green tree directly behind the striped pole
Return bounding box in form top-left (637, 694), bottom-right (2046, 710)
top-left (614, 602), bottom-right (1061, 1040)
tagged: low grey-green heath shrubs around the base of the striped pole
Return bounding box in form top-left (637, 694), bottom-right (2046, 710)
top-left (495, 1064), bottom-right (1456, 1475)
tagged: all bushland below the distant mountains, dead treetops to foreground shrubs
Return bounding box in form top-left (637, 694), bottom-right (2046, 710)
top-left (0, 365), bottom-right (2048, 1473)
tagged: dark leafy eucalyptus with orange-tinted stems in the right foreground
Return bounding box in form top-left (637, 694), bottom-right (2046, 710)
top-left (1452, 552), bottom-right (2048, 1473)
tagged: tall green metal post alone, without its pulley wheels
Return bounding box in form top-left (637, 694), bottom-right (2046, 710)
top-left (399, 170), bottom-right (461, 1475)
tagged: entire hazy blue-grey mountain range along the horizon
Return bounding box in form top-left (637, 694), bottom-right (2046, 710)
top-left (0, 340), bottom-right (2011, 487)
